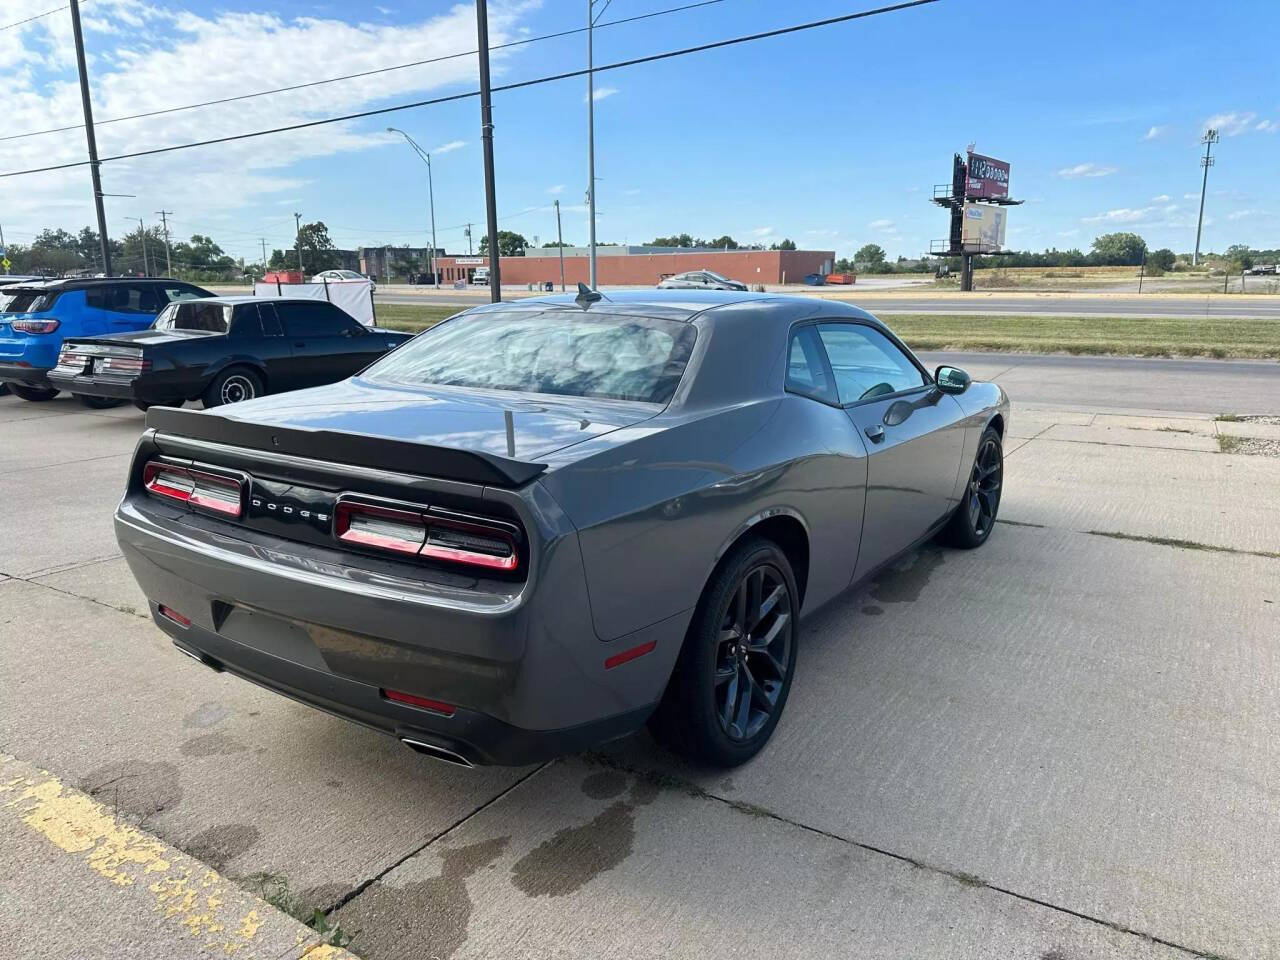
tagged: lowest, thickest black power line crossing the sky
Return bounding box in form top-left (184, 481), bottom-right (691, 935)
top-left (0, 0), bottom-right (938, 179)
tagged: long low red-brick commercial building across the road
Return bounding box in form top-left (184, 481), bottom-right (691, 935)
top-left (436, 246), bottom-right (836, 287)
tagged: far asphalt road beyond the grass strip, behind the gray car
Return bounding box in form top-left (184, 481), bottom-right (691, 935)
top-left (374, 289), bottom-right (1280, 320)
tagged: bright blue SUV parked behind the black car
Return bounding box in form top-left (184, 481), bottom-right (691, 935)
top-left (0, 276), bottom-right (214, 407)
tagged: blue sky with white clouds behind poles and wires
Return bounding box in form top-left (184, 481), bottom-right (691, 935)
top-left (0, 0), bottom-right (1280, 259)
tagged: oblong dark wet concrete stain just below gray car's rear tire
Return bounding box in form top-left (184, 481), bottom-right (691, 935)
top-left (511, 771), bottom-right (662, 897)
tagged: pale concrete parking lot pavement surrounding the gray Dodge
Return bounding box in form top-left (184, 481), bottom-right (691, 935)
top-left (0, 355), bottom-right (1280, 960)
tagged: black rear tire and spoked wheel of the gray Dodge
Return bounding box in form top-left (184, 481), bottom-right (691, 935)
top-left (649, 536), bottom-right (800, 767)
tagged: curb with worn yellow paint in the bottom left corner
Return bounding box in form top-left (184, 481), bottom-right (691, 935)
top-left (0, 754), bottom-right (355, 960)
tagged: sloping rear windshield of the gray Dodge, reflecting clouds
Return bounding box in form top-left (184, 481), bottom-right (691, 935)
top-left (365, 311), bottom-right (696, 403)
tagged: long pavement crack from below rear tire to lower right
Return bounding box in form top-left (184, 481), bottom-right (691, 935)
top-left (581, 753), bottom-right (1233, 960)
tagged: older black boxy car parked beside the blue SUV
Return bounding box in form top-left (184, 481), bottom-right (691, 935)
top-left (49, 297), bottom-right (411, 410)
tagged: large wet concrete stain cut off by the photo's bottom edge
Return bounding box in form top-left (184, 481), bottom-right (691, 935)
top-left (338, 837), bottom-right (511, 960)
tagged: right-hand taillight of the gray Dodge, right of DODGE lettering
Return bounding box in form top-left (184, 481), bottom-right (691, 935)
top-left (334, 499), bottom-right (520, 571)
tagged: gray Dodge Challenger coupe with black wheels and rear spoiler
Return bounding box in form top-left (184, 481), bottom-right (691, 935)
top-left (115, 288), bottom-right (1009, 765)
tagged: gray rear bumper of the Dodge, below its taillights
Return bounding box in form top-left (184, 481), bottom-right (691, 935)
top-left (115, 496), bottom-right (691, 764)
